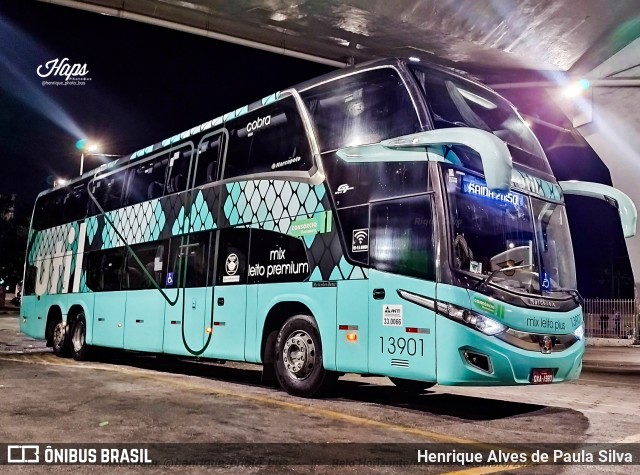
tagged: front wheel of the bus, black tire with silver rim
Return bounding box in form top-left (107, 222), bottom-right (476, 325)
top-left (274, 315), bottom-right (338, 397)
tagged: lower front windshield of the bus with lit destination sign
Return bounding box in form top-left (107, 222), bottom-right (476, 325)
top-left (445, 168), bottom-right (576, 295)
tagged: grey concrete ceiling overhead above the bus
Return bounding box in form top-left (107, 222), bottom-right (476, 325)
top-left (42, 0), bottom-right (640, 76)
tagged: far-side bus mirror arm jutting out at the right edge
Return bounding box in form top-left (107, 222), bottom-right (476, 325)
top-left (558, 180), bottom-right (638, 238)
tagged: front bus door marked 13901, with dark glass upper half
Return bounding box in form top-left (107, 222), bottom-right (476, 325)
top-left (368, 194), bottom-right (436, 381)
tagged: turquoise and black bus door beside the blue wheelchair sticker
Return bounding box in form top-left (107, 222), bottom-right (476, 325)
top-left (163, 232), bottom-right (212, 355)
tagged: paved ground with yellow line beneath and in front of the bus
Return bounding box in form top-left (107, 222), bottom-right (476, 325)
top-left (0, 315), bottom-right (640, 475)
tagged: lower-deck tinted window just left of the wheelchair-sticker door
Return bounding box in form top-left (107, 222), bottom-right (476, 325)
top-left (123, 241), bottom-right (168, 290)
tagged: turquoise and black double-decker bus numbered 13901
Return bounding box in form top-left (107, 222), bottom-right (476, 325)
top-left (21, 59), bottom-right (636, 396)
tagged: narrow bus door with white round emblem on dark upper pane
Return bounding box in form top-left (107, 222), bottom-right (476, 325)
top-left (206, 228), bottom-right (251, 361)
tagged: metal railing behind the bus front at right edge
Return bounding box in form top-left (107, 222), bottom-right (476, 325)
top-left (584, 299), bottom-right (640, 341)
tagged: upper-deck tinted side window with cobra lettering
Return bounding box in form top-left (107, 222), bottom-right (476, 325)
top-left (224, 98), bottom-right (312, 178)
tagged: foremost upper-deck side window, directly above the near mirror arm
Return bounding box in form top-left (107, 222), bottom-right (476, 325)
top-left (302, 68), bottom-right (420, 151)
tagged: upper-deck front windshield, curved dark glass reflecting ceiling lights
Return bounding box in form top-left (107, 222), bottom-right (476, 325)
top-left (412, 66), bottom-right (553, 175)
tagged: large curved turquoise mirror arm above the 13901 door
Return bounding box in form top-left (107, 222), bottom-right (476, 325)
top-left (380, 127), bottom-right (513, 192)
